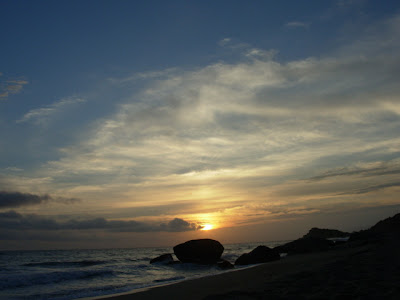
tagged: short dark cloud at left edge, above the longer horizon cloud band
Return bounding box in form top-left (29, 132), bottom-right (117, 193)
top-left (0, 191), bottom-right (78, 209)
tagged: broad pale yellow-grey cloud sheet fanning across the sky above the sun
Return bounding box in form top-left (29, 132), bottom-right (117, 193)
top-left (3, 16), bottom-right (400, 234)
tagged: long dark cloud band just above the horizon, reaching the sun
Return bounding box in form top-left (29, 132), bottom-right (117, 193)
top-left (0, 211), bottom-right (201, 232)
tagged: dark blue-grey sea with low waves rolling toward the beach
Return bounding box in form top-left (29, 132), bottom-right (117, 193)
top-left (0, 242), bottom-right (284, 300)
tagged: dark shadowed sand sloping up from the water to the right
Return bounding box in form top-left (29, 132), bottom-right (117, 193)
top-left (97, 240), bottom-right (400, 300)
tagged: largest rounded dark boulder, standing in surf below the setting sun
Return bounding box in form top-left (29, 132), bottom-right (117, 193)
top-left (174, 239), bottom-right (224, 264)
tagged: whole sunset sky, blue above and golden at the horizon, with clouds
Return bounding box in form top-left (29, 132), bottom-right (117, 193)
top-left (0, 0), bottom-right (400, 250)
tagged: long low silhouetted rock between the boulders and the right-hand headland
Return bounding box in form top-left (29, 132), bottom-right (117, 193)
top-left (274, 237), bottom-right (334, 255)
